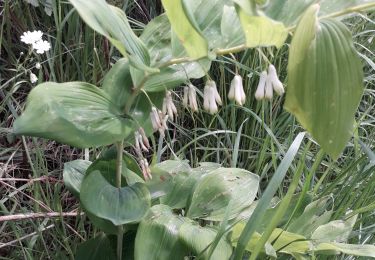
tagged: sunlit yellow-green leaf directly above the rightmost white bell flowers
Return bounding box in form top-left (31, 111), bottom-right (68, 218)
top-left (237, 8), bottom-right (288, 48)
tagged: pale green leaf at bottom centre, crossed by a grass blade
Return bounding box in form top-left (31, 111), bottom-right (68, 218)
top-left (179, 221), bottom-right (232, 260)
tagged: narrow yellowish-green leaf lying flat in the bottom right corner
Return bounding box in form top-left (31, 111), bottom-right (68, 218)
top-left (314, 242), bottom-right (375, 258)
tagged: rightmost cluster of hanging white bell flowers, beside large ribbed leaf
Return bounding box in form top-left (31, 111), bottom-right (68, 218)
top-left (255, 64), bottom-right (285, 100)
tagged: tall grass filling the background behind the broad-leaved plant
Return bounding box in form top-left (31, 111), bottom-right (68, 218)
top-left (0, 0), bottom-right (375, 259)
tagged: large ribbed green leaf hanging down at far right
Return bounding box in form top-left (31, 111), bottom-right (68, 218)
top-left (285, 5), bottom-right (363, 159)
